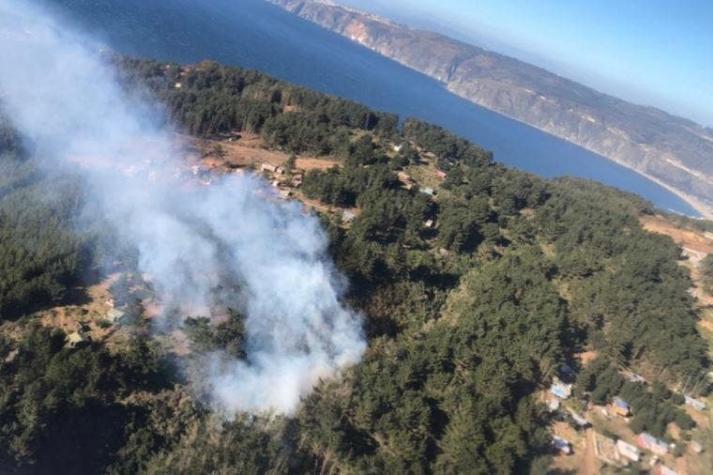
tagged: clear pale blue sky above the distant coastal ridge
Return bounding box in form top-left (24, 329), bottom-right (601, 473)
top-left (340, 0), bottom-right (713, 126)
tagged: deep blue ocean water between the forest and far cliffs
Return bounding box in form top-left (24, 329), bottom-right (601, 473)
top-left (44, 0), bottom-right (699, 216)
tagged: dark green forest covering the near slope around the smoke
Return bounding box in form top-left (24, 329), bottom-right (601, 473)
top-left (0, 58), bottom-right (713, 474)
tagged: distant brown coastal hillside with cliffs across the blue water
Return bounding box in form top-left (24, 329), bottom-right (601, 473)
top-left (268, 0), bottom-right (713, 216)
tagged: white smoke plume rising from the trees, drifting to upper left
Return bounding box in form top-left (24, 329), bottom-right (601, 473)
top-left (0, 0), bottom-right (365, 414)
